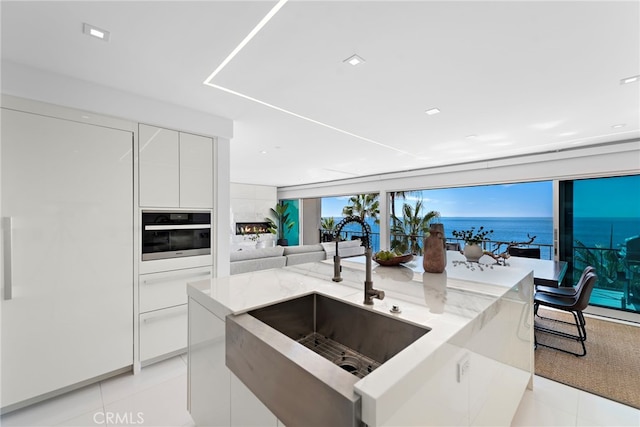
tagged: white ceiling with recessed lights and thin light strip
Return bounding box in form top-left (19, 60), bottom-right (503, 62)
top-left (1, 0), bottom-right (640, 186)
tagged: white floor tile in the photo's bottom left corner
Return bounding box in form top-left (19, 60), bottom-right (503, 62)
top-left (0, 384), bottom-right (103, 427)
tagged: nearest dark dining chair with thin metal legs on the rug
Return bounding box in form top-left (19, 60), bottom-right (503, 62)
top-left (533, 271), bottom-right (598, 357)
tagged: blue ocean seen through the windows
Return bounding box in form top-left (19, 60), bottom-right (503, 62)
top-left (334, 217), bottom-right (640, 259)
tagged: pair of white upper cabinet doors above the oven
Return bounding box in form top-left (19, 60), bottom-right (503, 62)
top-left (139, 124), bottom-right (213, 208)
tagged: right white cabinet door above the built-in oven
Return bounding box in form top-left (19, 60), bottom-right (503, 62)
top-left (180, 133), bottom-right (213, 208)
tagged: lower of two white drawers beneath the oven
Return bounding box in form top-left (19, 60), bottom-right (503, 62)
top-left (140, 304), bottom-right (188, 361)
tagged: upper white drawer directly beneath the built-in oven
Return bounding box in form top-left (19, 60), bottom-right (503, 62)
top-left (138, 267), bottom-right (211, 313)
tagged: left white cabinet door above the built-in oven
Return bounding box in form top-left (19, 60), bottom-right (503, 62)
top-left (138, 124), bottom-right (180, 208)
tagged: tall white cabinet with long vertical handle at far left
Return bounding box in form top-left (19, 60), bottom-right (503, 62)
top-left (1, 108), bottom-right (134, 410)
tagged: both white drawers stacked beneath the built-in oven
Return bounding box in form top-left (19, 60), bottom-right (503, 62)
top-left (138, 267), bottom-right (211, 363)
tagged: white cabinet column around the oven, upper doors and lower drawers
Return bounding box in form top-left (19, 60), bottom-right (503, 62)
top-left (137, 124), bottom-right (214, 366)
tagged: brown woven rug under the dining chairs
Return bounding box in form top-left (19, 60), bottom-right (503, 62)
top-left (535, 308), bottom-right (640, 409)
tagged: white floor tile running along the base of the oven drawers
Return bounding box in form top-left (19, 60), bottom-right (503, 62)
top-left (101, 356), bottom-right (187, 405)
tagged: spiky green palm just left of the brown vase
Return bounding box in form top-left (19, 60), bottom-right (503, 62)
top-left (391, 200), bottom-right (440, 255)
